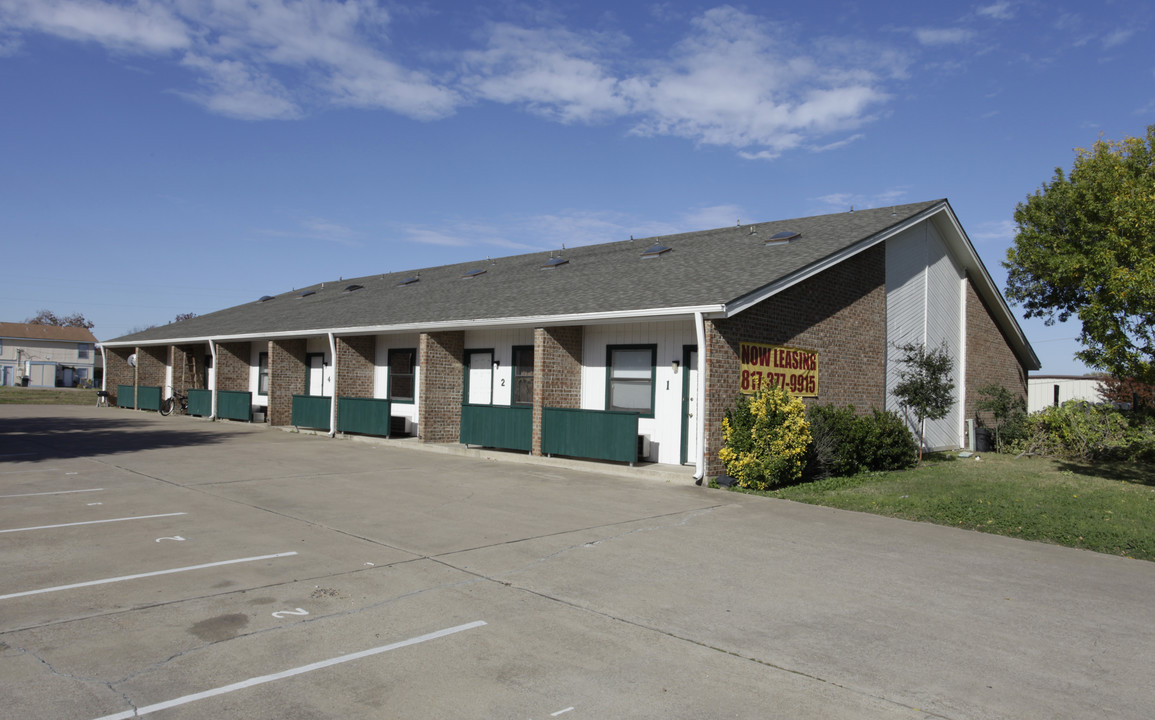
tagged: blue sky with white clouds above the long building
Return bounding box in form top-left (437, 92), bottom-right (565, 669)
top-left (0, 0), bottom-right (1155, 373)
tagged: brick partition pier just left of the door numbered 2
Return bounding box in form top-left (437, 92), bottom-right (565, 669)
top-left (417, 331), bottom-right (465, 443)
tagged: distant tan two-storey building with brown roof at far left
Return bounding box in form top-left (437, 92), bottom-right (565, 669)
top-left (0, 322), bottom-right (96, 387)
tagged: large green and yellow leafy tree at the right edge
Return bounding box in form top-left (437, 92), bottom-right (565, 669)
top-left (1004, 125), bottom-right (1155, 383)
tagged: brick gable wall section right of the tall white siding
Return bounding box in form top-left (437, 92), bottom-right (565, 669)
top-left (964, 277), bottom-right (1027, 426)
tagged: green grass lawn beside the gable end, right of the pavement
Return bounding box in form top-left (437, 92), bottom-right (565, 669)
top-left (742, 453), bottom-right (1155, 561)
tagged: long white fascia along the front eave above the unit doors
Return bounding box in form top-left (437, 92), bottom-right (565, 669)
top-left (98, 305), bottom-right (725, 348)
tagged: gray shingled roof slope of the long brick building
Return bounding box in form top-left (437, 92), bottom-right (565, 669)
top-left (107, 200), bottom-right (946, 344)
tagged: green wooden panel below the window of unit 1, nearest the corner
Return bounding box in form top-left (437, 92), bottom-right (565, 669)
top-left (542, 408), bottom-right (638, 462)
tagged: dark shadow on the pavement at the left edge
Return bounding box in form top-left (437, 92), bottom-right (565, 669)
top-left (0, 416), bottom-right (228, 463)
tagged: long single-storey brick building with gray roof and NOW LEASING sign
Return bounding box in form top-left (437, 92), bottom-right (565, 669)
top-left (102, 200), bottom-right (1040, 476)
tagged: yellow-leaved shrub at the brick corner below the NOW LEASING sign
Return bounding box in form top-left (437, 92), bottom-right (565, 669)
top-left (718, 386), bottom-right (811, 490)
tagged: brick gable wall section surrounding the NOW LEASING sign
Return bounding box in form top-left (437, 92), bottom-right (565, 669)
top-left (705, 240), bottom-right (886, 476)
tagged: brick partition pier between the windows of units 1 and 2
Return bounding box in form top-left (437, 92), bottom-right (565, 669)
top-left (531, 327), bottom-right (582, 455)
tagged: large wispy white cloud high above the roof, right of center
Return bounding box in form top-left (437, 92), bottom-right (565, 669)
top-left (464, 7), bottom-right (907, 158)
